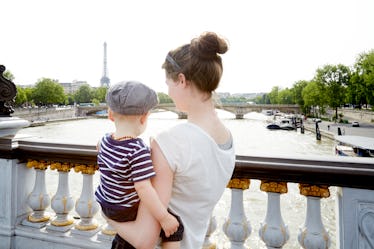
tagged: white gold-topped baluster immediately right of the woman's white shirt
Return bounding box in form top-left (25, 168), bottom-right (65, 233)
top-left (223, 179), bottom-right (252, 249)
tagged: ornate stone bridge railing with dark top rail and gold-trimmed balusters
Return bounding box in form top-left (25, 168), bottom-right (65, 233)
top-left (0, 138), bottom-right (374, 249)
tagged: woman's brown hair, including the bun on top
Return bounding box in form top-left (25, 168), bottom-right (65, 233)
top-left (162, 32), bottom-right (228, 93)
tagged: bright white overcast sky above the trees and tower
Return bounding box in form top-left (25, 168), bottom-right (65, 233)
top-left (0, 0), bottom-right (374, 94)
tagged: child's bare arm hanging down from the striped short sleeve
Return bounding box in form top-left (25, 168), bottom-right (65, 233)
top-left (134, 179), bottom-right (179, 237)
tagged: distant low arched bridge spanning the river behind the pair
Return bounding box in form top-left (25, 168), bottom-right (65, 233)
top-left (77, 103), bottom-right (301, 119)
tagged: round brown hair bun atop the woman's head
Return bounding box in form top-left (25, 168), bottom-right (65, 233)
top-left (190, 32), bottom-right (228, 60)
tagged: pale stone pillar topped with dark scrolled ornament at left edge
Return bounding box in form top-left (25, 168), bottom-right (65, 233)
top-left (0, 65), bottom-right (34, 249)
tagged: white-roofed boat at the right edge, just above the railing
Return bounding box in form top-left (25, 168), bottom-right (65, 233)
top-left (335, 135), bottom-right (374, 157)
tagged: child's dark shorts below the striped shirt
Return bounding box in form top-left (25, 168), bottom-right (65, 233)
top-left (108, 208), bottom-right (184, 249)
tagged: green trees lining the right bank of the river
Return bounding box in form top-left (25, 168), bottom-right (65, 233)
top-left (254, 50), bottom-right (374, 117)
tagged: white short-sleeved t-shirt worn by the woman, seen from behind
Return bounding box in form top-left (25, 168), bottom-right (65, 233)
top-left (155, 123), bottom-right (235, 249)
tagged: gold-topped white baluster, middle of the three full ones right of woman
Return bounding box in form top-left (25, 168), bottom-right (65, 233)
top-left (259, 181), bottom-right (290, 249)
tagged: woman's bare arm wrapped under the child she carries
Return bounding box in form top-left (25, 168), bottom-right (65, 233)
top-left (108, 140), bottom-right (173, 249)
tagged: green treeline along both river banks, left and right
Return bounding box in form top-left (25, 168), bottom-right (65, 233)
top-left (4, 50), bottom-right (374, 117)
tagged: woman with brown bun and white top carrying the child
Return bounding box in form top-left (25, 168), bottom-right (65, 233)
top-left (109, 32), bottom-right (235, 249)
